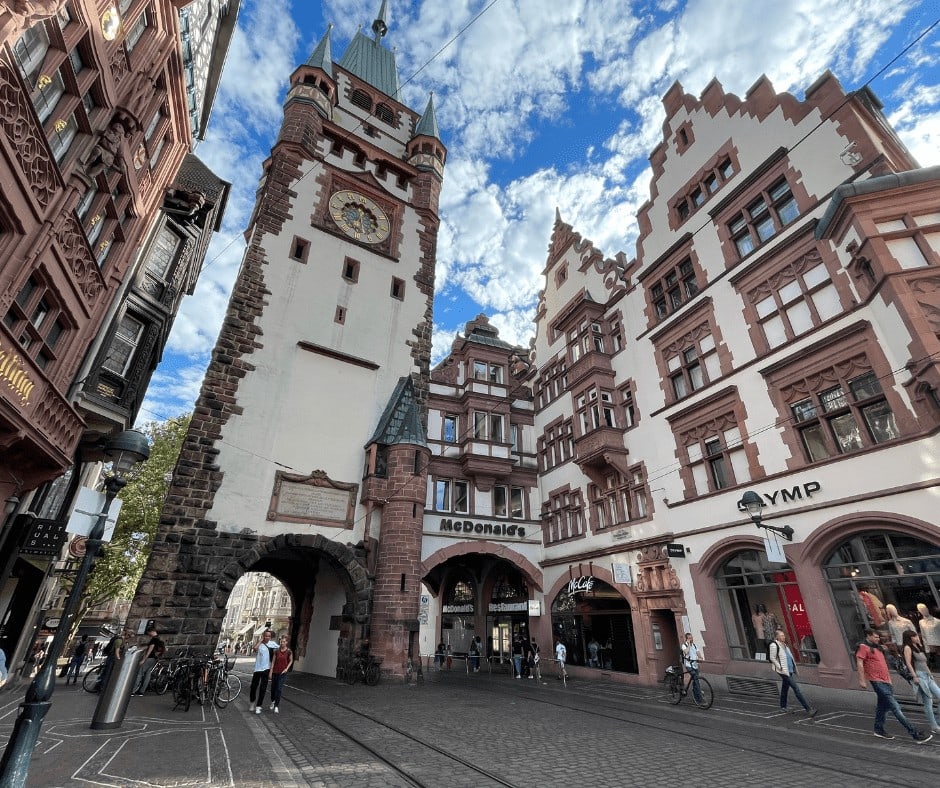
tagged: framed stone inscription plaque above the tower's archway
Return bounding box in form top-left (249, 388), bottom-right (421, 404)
top-left (268, 471), bottom-right (359, 528)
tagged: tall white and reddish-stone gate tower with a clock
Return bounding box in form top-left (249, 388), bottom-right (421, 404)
top-left (131, 2), bottom-right (446, 674)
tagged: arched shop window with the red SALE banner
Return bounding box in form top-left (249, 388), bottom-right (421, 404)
top-left (715, 550), bottom-right (819, 664)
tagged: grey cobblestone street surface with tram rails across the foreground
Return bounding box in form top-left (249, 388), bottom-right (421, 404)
top-left (0, 660), bottom-right (940, 788)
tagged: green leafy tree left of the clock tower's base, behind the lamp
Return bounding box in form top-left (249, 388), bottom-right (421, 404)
top-left (74, 414), bottom-right (192, 627)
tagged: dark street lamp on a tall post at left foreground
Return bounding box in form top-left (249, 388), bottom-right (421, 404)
top-left (0, 430), bottom-right (150, 788)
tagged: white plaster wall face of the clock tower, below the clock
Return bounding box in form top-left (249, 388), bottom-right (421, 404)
top-left (208, 157), bottom-right (426, 542)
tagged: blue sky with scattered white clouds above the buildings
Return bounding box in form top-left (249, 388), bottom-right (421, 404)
top-left (140, 0), bottom-right (940, 421)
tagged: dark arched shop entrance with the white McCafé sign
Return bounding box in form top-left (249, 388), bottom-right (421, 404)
top-left (552, 577), bottom-right (639, 673)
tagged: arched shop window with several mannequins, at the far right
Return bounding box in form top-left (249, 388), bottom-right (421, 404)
top-left (824, 531), bottom-right (940, 655)
